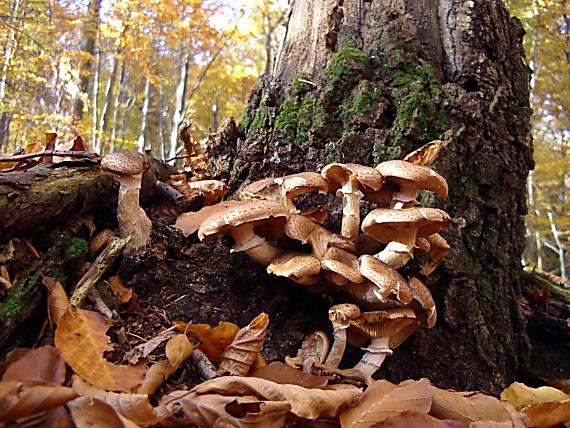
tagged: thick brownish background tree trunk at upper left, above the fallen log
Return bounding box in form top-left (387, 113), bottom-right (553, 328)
top-left (72, 0), bottom-right (101, 125)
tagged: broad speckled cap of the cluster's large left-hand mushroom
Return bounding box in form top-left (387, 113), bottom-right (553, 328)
top-left (198, 201), bottom-right (289, 240)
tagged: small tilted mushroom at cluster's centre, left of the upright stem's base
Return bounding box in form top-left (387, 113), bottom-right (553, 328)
top-left (285, 214), bottom-right (356, 260)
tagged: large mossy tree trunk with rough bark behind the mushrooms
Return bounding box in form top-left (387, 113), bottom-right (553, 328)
top-left (209, 0), bottom-right (533, 392)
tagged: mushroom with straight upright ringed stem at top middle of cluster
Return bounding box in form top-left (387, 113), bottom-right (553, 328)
top-left (321, 163), bottom-right (382, 242)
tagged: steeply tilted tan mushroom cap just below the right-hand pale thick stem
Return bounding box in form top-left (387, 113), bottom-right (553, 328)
top-left (360, 255), bottom-right (413, 304)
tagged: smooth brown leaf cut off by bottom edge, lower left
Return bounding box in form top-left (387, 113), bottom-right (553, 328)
top-left (67, 397), bottom-right (138, 428)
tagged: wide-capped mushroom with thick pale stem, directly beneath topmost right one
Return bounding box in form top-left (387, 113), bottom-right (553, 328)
top-left (362, 208), bottom-right (451, 269)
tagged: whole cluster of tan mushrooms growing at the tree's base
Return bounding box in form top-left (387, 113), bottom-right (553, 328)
top-left (177, 148), bottom-right (450, 375)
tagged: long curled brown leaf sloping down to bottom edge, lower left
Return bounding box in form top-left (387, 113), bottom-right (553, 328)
top-left (72, 376), bottom-right (157, 426)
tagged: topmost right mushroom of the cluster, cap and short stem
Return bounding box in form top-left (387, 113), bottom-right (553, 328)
top-left (376, 160), bottom-right (448, 209)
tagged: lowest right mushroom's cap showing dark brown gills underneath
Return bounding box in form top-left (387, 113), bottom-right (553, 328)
top-left (349, 308), bottom-right (420, 349)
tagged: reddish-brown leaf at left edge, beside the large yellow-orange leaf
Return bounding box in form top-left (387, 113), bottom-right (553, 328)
top-left (2, 346), bottom-right (65, 385)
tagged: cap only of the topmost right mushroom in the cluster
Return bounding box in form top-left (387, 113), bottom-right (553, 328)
top-left (376, 160), bottom-right (448, 198)
